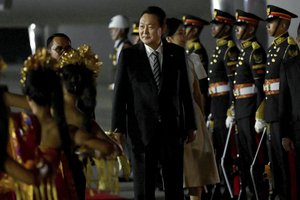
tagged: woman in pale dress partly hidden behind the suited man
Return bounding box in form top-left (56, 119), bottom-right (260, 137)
top-left (165, 18), bottom-right (220, 200)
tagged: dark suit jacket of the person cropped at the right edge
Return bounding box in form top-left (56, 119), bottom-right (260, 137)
top-left (279, 56), bottom-right (300, 137)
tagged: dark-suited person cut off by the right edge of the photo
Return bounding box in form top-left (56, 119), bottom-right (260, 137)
top-left (275, 55), bottom-right (300, 199)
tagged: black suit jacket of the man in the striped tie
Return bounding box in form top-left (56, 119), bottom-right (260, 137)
top-left (112, 43), bottom-right (196, 146)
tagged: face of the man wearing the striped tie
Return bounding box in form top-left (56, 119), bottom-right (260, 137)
top-left (139, 13), bottom-right (163, 49)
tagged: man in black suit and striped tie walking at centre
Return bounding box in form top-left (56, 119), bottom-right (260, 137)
top-left (112, 6), bottom-right (196, 200)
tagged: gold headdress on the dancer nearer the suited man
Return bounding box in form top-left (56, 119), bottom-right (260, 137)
top-left (59, 44), bottom-right (102, 77)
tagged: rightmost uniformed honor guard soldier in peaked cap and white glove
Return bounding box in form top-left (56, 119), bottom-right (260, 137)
top-left (255, 5), bottom-right (299, 199)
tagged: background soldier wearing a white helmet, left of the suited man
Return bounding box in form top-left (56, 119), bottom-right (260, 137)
top-left (108, 15), bottom-right (132, 90)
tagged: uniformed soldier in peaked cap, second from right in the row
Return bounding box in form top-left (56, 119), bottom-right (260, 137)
top-left (227, 10), bottom-right (266, 199)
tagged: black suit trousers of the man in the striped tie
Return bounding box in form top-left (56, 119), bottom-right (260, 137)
top-left (132, 136), bottom-right (184, 200)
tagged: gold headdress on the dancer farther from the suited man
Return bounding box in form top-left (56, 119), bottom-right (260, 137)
top-left (20, 48), bottom-right (57, 85)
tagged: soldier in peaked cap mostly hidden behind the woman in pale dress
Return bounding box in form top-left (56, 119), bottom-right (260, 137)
top-left (182, 15), bottom-right (210, 117)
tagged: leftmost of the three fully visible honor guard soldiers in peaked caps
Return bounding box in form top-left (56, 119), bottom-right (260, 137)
top-left (208, 9), bottom-right (239, 199)
